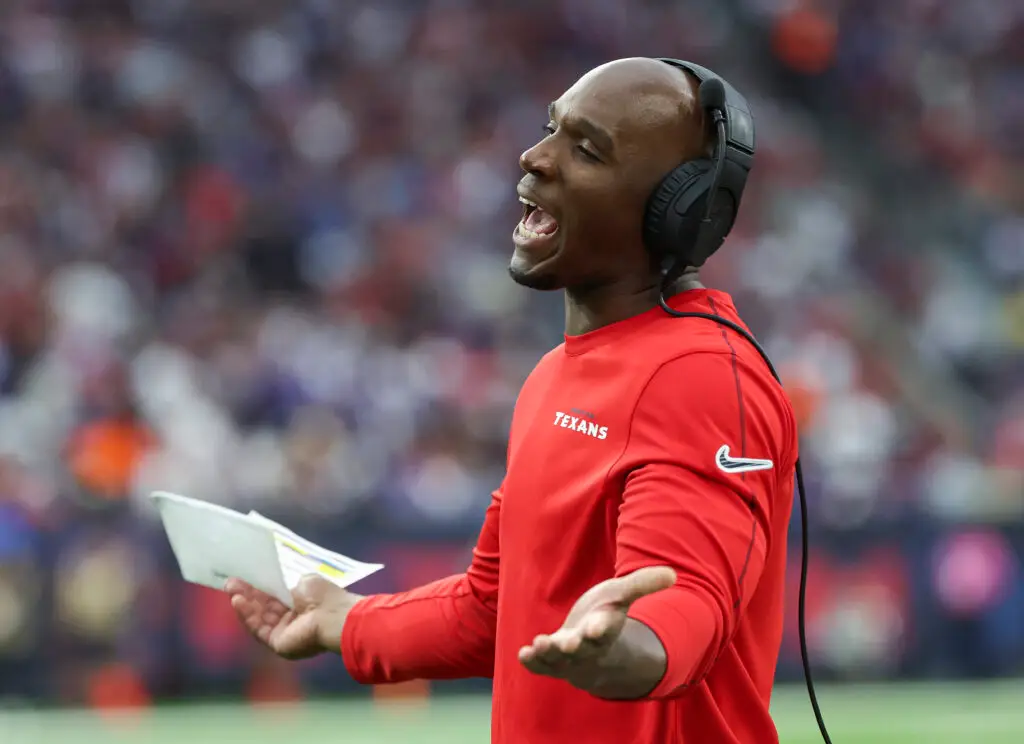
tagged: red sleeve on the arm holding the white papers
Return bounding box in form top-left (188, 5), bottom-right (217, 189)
top-left (341, 488), bottom-right (502, 685)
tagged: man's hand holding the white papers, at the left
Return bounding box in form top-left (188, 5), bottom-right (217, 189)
top-left (224, 576), bottom-right (362, 659)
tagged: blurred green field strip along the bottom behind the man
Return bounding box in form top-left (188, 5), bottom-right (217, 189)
top-left (0, 681), bottom-right (1024, 744)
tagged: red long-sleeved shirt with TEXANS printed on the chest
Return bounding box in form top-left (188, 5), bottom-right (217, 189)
top-left (342, 290), bottom-right (798, 744)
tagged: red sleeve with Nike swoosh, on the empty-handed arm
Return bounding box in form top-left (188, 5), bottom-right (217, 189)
top-left (615, 352), bottom-right (793, 698)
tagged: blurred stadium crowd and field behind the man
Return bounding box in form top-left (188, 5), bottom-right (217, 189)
top-left (0, 0), bottom-right (1024, 744)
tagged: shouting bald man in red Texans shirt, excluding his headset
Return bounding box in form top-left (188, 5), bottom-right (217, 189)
top-left (227, 58), bottom-right (797, 744)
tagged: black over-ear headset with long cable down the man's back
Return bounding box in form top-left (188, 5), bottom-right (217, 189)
top-left (643, 57), bottom-right (831, 744)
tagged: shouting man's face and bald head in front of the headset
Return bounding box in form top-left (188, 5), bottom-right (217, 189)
top-left (509, 59), bottom-right (699, 290)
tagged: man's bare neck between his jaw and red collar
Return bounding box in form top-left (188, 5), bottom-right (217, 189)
top-left (565, 268), bottom-right (703, 336)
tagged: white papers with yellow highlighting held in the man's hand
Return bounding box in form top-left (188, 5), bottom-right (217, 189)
top-left (153, 491), bottom-right (384, 607)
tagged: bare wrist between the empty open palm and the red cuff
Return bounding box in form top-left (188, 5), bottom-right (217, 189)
top-left (570, 618), bottom-right (668, 700)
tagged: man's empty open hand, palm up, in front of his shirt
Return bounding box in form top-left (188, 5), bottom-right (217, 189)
top-left (519, 566), bottom-right (676, 690)
